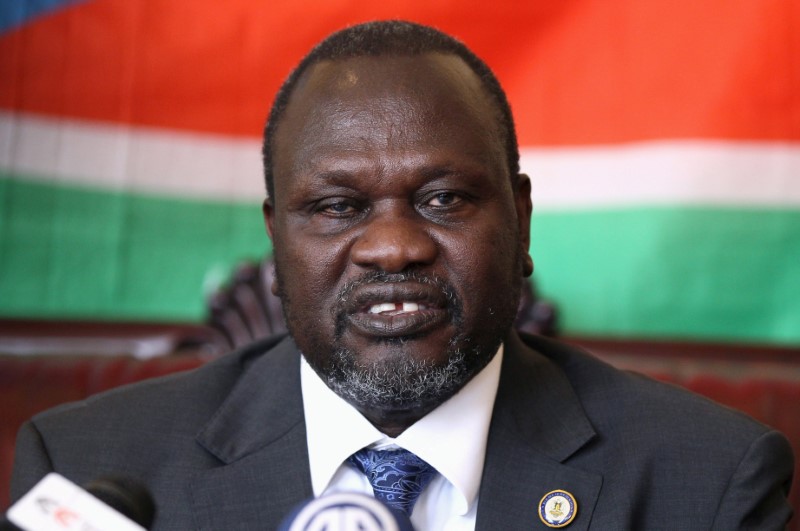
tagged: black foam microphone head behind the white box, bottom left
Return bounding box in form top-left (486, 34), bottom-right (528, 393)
top-left (83, 476), bottom-right (156, 529)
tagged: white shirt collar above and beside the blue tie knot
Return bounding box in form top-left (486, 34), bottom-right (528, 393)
top-left (300, 345), bottom-right (503, 514)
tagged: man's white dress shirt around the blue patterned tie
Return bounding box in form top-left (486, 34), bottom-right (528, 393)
top-left (300, 346), bottom-right (503, 531)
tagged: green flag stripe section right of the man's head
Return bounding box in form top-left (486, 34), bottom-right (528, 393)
top-left (531, 207), bottom-right (800, 344)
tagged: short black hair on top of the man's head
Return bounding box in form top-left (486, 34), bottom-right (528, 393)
top-left (261, 20), bottom-right (519, 201)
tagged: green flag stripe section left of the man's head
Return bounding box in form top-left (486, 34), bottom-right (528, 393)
top-left (0, 175), bottom-right (271, 320)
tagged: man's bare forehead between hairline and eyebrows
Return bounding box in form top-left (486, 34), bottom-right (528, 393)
top-left (273, 54), bottom-right (505, 184)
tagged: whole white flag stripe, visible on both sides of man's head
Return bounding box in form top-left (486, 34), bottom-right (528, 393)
top-left (0, 112), bottom-right (800, 211)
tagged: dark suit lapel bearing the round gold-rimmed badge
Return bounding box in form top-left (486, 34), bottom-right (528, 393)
top-left (476, 333), bottom-right (602, 531)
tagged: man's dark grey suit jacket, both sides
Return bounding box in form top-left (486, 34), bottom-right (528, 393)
top-left (12, 334), bottom-right (792, 531)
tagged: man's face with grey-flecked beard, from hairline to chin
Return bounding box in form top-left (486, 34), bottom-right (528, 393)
top-left (265, 54), bottom-right (530, 428)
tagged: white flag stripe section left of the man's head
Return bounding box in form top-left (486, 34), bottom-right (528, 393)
top-left (0, 113), bottom-right (265, 202)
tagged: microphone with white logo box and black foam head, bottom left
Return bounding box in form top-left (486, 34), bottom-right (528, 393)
top-left (0, 472), bottom-right (155, 531)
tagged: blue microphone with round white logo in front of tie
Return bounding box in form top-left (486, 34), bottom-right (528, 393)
top-left (278, 492), bottom-right (414, 531)
